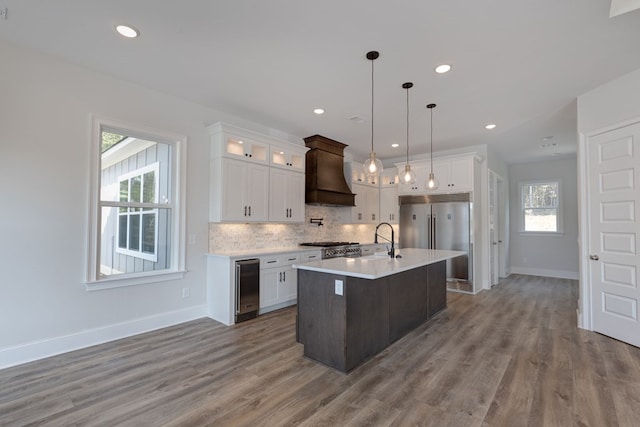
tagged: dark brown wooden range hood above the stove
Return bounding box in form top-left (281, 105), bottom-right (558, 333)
top-left (304, 135), bottom-right (355, 206)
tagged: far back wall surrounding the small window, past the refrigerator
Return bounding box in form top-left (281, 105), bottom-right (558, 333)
top-left (509, 158), bottom-right (578, 279)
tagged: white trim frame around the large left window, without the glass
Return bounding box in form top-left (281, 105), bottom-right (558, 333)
top-left (85, 115), bottom-right (187, 291)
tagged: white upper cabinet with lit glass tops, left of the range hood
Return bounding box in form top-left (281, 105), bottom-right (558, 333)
top-left (208, 123), bottom-right (307, 222)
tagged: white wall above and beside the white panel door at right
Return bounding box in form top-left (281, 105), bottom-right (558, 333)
top-left (578, 69), bottom-right (640, 329)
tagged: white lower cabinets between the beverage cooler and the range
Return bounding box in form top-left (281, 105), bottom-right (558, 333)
top-left (259, 253), bottom-right (300, 314)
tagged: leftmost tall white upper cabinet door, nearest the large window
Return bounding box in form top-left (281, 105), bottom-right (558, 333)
top-left (222, 160), bottom-right (248, 221)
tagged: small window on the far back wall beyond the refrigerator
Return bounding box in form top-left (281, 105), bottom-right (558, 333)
top-left (520, 181), bottom-right (562, 233)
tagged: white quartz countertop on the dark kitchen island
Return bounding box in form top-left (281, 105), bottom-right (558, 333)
top-left (293, 248), bottom-right (466, 279)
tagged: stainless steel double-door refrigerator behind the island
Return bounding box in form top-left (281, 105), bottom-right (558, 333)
top-left (399, 193), bottom-right (473, 292)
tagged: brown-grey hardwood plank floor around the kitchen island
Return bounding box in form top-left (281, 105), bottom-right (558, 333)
top-left (0, 275), bottom-right (640, 427)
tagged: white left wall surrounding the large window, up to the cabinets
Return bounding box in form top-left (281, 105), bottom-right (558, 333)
top-left (0, 39), bottom-right (292, 368)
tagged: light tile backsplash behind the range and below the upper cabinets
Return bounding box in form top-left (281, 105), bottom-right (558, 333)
top-left (209, 205), bottom-right (388, 253)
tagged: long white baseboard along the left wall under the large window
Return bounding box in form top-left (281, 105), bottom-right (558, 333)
top-left (0, 305), bottom-right (208, 369)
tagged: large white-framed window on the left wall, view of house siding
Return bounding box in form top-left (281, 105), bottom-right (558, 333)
top-left (87, 119), bottom-right (185, 290)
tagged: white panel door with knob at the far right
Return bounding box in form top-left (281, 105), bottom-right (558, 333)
top-left (587, 123), bottom-right (640, 347)
